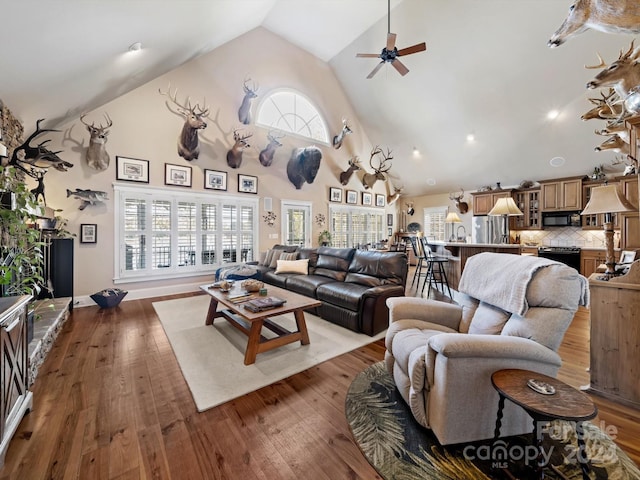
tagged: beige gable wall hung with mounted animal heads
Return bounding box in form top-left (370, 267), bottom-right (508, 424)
top-left (37, 28), bottom-right (398, 298)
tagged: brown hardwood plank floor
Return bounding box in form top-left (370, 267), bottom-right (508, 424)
top-left (0, 274), bottom-right (640, 480)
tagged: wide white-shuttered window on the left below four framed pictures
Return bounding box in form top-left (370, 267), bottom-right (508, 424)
top-left (114, 185), bottom-right (258, 281)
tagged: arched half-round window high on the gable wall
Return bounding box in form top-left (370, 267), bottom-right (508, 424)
top-left (256, 89), bottom-right (329, 144)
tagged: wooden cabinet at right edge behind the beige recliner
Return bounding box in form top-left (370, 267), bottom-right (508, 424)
top-left (588, 270), bottom-right (640, 408)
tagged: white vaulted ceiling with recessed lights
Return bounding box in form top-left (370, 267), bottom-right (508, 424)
top-left (0, 0), bottom-right (632, 195)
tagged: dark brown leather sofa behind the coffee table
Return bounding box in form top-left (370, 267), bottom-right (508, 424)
top-left (254, 245), bottom-right (408, 336)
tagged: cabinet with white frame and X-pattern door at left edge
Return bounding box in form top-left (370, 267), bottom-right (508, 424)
top-left (0, 295), bottom-right (33, 468)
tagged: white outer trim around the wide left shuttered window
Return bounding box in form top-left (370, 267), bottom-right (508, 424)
top-left (113, 183), bottom-right (260, 284)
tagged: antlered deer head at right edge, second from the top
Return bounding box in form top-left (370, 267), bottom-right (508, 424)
top-left (585, 41), bottom-right (640, 99)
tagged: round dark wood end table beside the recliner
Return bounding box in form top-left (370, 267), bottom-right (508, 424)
top-left (491, 369), bottom-right (598, 480)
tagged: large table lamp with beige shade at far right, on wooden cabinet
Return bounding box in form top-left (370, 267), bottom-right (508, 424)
top-left (581, 185), bottom-right (635, 275)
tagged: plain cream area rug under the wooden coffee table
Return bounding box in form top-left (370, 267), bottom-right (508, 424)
top-left (153, 295), bottom-right (384, 412)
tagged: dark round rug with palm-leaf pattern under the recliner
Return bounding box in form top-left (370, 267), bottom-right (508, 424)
top-left (346, 362), bottom-right (640, 480)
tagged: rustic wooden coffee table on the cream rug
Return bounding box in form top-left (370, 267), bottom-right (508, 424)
top-left (200, 282), bottom-right (321, 365)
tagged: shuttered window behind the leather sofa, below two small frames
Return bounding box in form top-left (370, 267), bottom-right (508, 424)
top-left (329, 205), bottom-right (387, 247)
